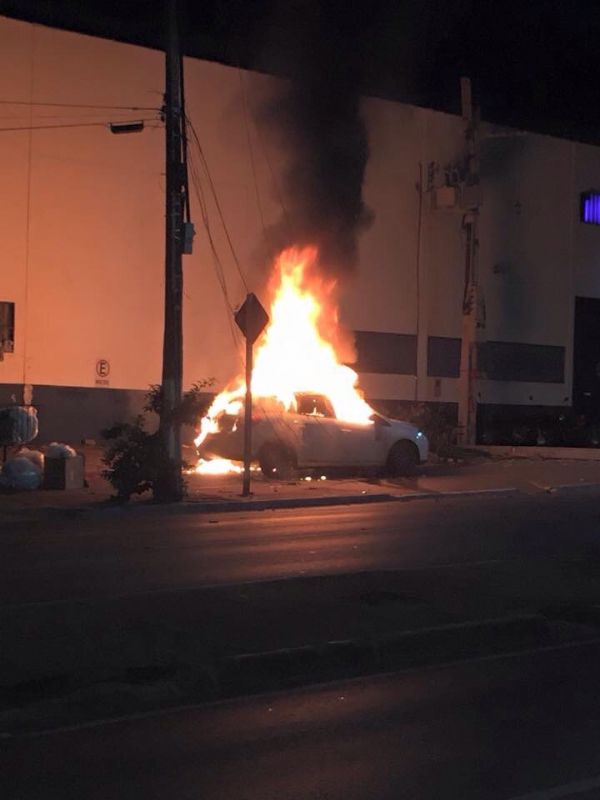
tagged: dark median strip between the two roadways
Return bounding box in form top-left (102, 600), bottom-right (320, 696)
top-left (0, 566), bottom-right (600, 734)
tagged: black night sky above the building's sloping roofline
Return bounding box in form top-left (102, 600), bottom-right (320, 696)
top-left (0, 0), bottom-right (600, 142)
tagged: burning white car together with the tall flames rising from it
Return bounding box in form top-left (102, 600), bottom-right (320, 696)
top-left (196, 247), bottom-right (429, 478)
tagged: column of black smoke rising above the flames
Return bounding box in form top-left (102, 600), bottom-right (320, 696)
top-left (261, 2), bottom-right (372, 274)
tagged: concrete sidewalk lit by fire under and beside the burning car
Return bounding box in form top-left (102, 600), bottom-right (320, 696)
top-left (0, 448), bottom-right (600, 519)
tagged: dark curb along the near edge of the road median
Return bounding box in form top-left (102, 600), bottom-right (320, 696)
top-left (0, 614), bottom-right (564, 737)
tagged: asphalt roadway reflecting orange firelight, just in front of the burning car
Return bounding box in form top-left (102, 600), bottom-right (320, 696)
top-left (0, 490), bottom-right (600, 605)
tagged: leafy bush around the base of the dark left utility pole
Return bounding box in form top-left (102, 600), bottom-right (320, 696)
top-left (102, 379), bottom-right (214, 501)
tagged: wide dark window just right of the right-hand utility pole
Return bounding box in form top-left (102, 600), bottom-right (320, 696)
top-left (477, 342), bottom-right (565, 383)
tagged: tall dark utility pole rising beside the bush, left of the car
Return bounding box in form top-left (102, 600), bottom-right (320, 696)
top-left (155, 0), bottom-right (186, 502)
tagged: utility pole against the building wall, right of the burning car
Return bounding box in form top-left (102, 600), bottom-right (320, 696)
top-left (458, 78), bottom-right (481, 445)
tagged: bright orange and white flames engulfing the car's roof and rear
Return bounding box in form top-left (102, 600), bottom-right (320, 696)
top-left (196, 247), bottom-right (373, 471)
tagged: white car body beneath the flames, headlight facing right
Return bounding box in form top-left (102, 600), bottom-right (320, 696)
top-left (198, 393), bottom-right (429, 479)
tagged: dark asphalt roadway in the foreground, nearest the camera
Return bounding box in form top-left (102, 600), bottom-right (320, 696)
top-left (7, 645), bottom-right (600, 800)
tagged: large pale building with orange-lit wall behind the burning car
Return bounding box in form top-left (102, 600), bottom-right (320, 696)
top-left (0, 17), bottom-right (600, 440)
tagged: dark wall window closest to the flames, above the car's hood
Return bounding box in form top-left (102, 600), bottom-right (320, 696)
top-left (352, 331), bottom-right (417, 375)
